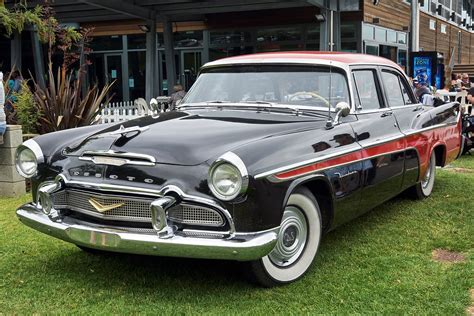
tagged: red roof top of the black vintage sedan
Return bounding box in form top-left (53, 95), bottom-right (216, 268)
top-left (217, 51), bottom-right (399, 68)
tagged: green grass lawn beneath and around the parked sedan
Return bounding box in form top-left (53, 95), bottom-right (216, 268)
top-left (0, 156), bottom-right (474, 315)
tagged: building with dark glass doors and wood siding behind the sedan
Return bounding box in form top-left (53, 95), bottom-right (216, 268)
top-left (0, 0), bottom-right (474, 101)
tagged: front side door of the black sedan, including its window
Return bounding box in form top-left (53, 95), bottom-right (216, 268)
top-left (351, 66), bottom-right (405, 213)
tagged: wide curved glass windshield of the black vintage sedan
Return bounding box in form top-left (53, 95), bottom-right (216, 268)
top-left (182, 65), bottom-right (349, 109)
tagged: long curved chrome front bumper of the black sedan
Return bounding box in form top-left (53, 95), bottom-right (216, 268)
top-left (16, 204), bottom-right (279, 261)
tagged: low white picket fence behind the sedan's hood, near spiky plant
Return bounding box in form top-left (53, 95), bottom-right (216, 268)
top-left (96, 97), bottom-right (168, 124)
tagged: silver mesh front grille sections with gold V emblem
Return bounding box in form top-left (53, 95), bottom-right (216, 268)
top-left (52, 189), bottom-right (225, 227)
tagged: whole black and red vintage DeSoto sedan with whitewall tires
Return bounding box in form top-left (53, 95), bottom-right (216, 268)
top-left (17, 52), bottom-right (462, 286)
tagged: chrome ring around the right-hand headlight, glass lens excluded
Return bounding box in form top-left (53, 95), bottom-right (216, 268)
top-left (207, 152), bottom-right (249, 201)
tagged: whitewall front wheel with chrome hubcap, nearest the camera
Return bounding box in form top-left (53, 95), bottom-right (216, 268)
top-left (250, 188), bottom-right (322, 287)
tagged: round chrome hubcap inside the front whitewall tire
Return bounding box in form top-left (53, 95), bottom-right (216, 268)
top-left (268, 206), bottom-right (308, 267)
